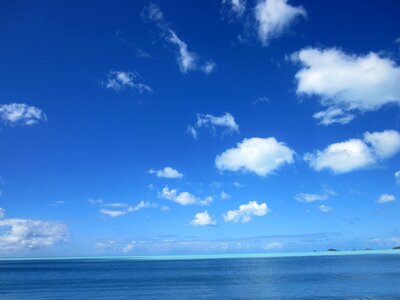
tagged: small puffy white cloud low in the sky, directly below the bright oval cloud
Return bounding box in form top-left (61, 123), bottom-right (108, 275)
top-left (224, 201), bottom-right (270, 223)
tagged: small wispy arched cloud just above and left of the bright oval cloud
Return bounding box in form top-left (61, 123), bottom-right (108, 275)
top-left (187, 113), bottom-right (239, 139)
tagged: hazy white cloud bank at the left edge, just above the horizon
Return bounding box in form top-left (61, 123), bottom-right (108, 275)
top-left (0, 210), bottom-right (68, 251)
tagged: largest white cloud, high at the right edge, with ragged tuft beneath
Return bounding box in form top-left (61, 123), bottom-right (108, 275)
top-left (292, 48), bottom-right (400, 125)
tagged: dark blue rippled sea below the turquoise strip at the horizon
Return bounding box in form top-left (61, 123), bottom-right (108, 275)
top-left (0, 255), bottom-right (400, 299)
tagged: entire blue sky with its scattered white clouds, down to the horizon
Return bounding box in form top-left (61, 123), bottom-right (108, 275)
top-left (0, 0), bottom-right (400, 256)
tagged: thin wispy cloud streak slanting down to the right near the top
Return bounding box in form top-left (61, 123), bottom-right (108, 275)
top-left (142, 3), bottom-right (215, 74)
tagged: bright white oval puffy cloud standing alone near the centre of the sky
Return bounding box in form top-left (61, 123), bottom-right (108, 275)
top-left (215, 137), bottom-right (295, 176)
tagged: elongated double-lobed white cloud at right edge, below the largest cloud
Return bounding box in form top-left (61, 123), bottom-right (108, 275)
top-left (304, 130), bottom-right (400, 174)
